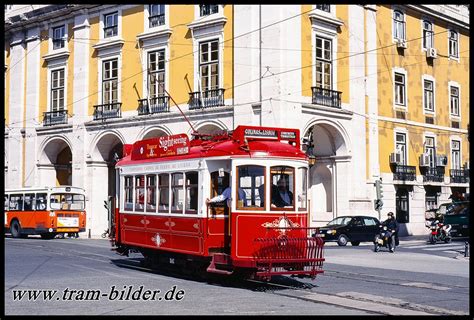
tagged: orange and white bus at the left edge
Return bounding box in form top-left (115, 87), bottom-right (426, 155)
top-left (5, 186), bottom-right (86, 239)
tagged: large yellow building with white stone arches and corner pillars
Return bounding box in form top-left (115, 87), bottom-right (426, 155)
top-left (4, 4), bottom-right (469, 235)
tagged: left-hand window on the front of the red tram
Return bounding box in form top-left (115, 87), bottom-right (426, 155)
top-left (236, 165), bottom-right (265, 210)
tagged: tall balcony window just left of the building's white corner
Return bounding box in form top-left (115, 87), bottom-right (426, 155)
top-left (199, 40), bottom-right (219, 93)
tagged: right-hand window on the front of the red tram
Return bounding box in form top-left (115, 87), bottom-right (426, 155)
top-left (270, 166), bottom-right (295, 210)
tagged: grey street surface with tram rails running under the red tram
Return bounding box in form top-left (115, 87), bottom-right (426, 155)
top-left (5, 237), bottom-right (469, 315)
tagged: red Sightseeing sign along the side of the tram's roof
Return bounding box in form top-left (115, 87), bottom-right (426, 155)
top-left (132, 134), bottom-right (190, 160)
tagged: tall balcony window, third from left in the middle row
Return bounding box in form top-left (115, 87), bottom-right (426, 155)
top-left (148, 50), bottom-right (165, 98)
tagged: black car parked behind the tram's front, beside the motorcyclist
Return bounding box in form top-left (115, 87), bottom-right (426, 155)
top-left (319, 216), bottom-right (380, 246)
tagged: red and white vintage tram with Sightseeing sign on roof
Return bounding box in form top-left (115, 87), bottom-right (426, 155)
top-left (111, 126), bottom-right (324, 280)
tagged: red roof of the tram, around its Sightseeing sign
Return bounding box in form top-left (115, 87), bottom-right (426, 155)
top-left (117, 126), bottom-right (306, 167)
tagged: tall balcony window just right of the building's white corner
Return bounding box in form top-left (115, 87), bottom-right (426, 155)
top-left (316, 37), bottom-right (332, 90)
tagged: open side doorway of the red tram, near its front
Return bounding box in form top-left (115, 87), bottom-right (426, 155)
top-left (208, 171), bottom-right (230, 254)
